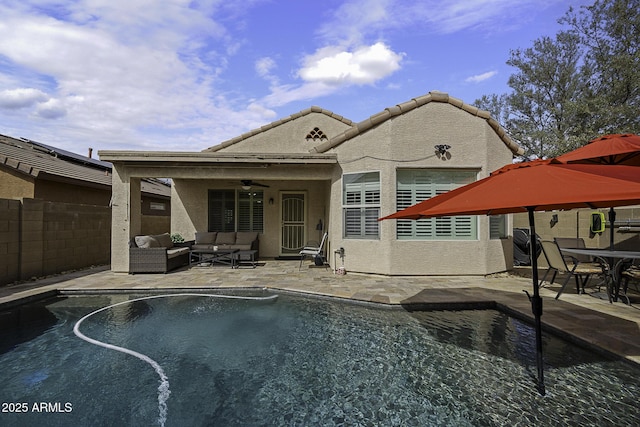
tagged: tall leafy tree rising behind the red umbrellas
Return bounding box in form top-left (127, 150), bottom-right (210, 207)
top-left (475, 0), bottom-right (640, 158)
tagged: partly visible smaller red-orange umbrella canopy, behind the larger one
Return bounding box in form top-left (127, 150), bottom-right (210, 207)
top-left (556, 133), bottom-right (640, 166)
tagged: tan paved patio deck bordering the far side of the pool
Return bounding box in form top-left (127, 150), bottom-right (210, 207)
top-left (0, 259), bottom-right (640, 364)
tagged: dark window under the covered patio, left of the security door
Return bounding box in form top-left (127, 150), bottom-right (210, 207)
top-left (209, 190), bottom-right (264, 232)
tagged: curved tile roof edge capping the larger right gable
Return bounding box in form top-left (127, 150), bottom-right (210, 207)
top-left (310, 91), bottom-right (524, 155)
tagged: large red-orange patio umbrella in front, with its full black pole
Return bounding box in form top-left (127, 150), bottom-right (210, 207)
top-left (381, 159), bottom-right (640, 395)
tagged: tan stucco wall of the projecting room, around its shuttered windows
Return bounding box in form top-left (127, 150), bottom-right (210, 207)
top-left (330, 103), bottom-right (513, 275)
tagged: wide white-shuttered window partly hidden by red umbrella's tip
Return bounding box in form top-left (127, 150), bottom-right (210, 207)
top-left (396, 169), bottom-right (478, 240)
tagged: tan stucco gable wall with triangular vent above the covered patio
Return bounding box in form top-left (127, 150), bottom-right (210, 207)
top-left (219, 113), bottom-right (350, 153)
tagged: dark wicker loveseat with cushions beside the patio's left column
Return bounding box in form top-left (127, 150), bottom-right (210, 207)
top-left (129, 233), bottom-right (189, 273)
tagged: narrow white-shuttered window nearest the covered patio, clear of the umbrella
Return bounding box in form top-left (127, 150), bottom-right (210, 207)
top-left (342, 172), bottom-right (380, 239)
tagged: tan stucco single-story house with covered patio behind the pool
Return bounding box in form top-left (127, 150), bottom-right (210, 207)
top-left (99, 92), bottom-right (522, 275)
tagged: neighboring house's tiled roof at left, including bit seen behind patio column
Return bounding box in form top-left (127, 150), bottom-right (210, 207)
top-left (0, 135), bottom-right (171, 197)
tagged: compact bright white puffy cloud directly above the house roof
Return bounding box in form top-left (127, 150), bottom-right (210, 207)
top-left (298, 43), bottom-right (403, 85)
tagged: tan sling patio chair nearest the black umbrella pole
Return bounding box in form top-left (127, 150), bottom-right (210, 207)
top-left (539, 240), bottom-right (604, 299)
